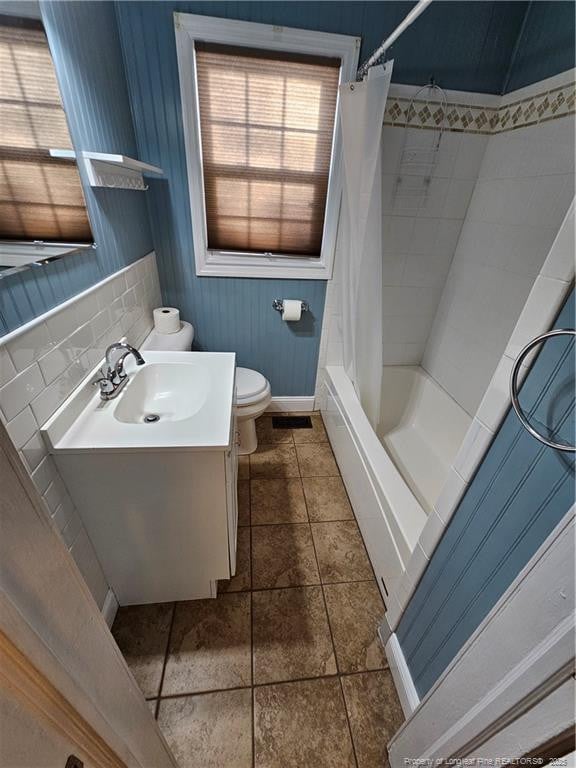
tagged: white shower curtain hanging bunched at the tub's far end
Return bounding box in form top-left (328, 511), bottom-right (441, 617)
top-left (338, 61), bottom-right (393, 429)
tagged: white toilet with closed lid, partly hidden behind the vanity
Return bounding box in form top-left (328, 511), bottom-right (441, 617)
top-left (140, 322), bottom-right (272, 456)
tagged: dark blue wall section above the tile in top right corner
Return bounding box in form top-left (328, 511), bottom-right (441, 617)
top-left (504, 0), bottom-right (576, 93)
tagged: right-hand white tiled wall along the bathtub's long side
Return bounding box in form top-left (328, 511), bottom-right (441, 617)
top-left (422, 71), bottom-right (574, 416)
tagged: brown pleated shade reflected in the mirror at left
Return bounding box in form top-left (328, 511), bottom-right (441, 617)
top-left (0, 16), bottom-right (92, 243)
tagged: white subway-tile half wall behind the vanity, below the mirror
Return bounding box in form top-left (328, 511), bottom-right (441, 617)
top-left (0, 253), bottom-right (162, 607)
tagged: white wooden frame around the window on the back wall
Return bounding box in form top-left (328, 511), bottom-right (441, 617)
top-left (174, 12), bottom-right (361, 280)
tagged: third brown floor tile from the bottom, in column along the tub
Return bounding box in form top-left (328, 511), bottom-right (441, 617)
top-left (310, 520), bottom-right (374, 583)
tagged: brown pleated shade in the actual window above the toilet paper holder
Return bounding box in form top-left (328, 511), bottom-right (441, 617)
top-left (195, 42), bottom-right (340, 257)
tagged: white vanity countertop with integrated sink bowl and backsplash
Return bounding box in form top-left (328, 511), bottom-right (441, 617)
top-left (42, 350), bottom-right (236, 453)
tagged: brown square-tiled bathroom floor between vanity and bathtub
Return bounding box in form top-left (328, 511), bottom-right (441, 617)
top-left (113, 414), bottom-right (403, 768)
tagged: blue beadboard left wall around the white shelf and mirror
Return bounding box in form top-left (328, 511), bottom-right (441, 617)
top-left (0, 2), bottom-right (152, 334)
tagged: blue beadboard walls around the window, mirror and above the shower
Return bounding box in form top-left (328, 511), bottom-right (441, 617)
top-left (0, 0), bottom-right (574, 395)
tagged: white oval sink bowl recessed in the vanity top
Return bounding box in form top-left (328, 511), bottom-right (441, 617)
top-left (114, 363), bottom-right (210, 426)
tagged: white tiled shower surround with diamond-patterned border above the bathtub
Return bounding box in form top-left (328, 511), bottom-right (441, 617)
top-left (317, 71), bottom-right (574, 404)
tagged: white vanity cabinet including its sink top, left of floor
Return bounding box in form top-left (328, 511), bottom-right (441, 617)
top-left (42, 351), bottom-right (238, 605)
